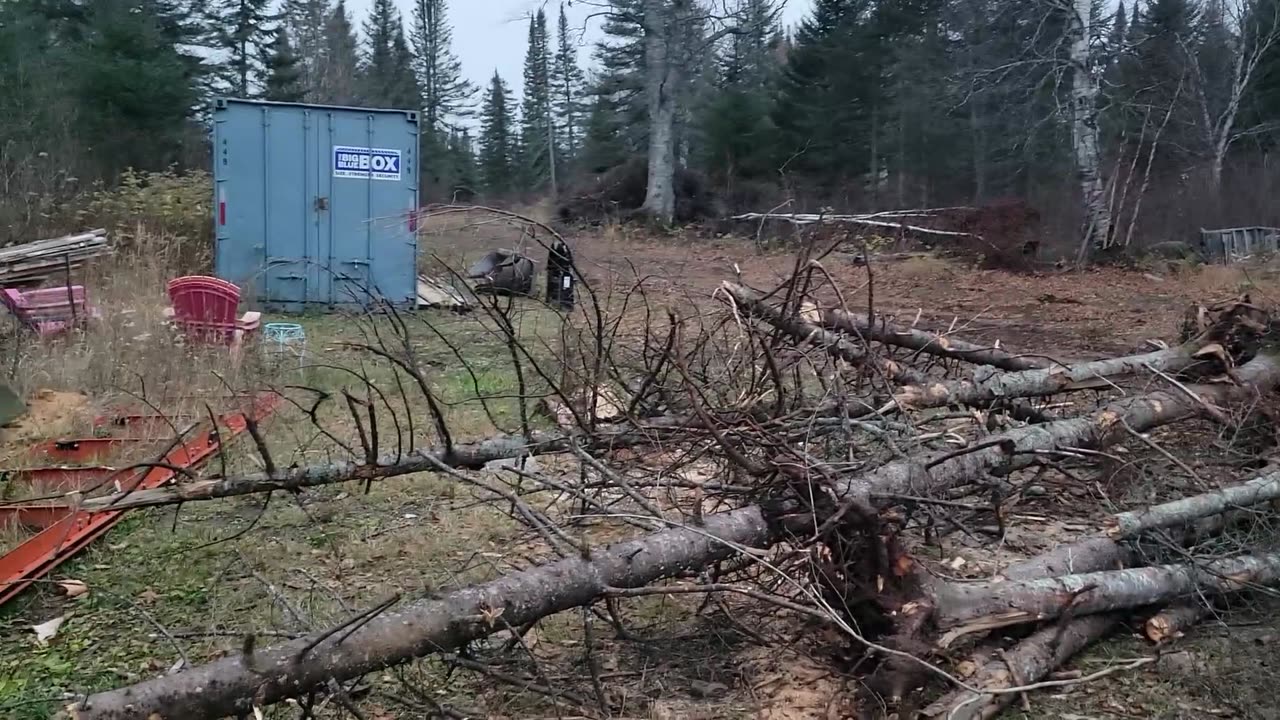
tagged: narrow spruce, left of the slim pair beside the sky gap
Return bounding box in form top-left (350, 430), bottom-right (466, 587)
top-left (520, 9), bottom-right (556, 192)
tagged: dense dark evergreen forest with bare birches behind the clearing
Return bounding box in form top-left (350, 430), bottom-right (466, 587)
top-left (0, 0), bottom-right (1280, 256)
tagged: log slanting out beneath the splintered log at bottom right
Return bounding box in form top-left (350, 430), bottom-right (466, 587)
top-left (920, 615), bottom-right (1119, 720)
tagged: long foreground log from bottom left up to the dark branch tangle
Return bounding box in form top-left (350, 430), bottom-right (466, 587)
top-left (67, 507), bottom-right (776, 720)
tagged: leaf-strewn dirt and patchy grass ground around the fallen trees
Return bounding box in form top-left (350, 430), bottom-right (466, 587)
top-left (0, 228), bottom-right (1280, 720)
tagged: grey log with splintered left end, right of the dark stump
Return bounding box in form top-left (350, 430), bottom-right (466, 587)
top-left (933, 545), bottom-right (1280, 647)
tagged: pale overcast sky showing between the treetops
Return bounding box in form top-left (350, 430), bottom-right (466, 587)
top-left (347, 0), bottom-right (812, 94)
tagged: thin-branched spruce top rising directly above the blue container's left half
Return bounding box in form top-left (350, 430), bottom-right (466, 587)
top-left (210, 0), bottom-right (275, 97)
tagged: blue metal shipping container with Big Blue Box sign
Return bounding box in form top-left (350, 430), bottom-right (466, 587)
top-left (214, 99), bottom-right (419, 311)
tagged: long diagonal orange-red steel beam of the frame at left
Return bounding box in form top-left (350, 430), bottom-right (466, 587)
top-left (0, 393), bottom-right (280, 605)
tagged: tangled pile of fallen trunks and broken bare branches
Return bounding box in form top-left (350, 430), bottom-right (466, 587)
top-left (68, 257), bottom-right (1280, 720)
